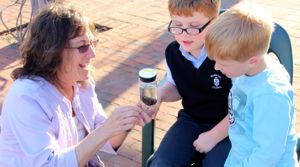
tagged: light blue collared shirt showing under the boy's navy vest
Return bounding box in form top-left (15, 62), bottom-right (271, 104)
top-left (166, 46), bottom-right (207, 86)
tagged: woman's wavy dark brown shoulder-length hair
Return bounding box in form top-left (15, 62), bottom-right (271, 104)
top-left (12, 4), bottom-right (93, 83)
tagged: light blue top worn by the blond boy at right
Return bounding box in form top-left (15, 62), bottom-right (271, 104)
top-left (225, 59), bottom-right (298, 167)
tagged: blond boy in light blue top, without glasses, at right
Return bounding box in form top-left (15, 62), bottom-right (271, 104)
top-left (205, 3), bottom-right (298, 167)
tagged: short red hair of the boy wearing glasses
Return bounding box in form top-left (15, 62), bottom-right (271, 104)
top-left (168, 0), bottom-right (221, 18)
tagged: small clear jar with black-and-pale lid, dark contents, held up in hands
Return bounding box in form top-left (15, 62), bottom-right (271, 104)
top-left (139, 68), bottom-right (157, 106)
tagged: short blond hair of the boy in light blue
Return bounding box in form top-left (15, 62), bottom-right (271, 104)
top-left (205, 2), bottom-right (274, 61)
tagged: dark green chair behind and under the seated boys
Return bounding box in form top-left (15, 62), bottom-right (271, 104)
top-left (142, 20), bottom-right (300, 167)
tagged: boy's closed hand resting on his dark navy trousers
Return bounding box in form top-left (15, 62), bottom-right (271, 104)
top-left (193, 131), bottom-right (217, 153)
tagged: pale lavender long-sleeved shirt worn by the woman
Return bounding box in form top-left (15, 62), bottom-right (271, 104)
top-left (0, 77), bottom-right (114, 167)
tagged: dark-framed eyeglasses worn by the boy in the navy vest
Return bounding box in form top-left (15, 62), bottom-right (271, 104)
top-left (168, 19), bottom-right (212, 35)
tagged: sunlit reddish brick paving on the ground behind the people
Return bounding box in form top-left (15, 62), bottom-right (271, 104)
top-left (0, 0), bottom-right (300, 167)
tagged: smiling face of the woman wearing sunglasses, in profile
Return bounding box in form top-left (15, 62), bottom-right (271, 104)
top-left (57, 29), bottom-right (96, 84)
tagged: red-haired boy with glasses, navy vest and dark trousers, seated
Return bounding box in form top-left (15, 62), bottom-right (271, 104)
top-left (145, 0), bottom-right (231, 167)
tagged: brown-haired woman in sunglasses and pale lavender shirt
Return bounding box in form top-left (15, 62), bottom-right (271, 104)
top-left (0, 4), bottom-right (138, 167)
